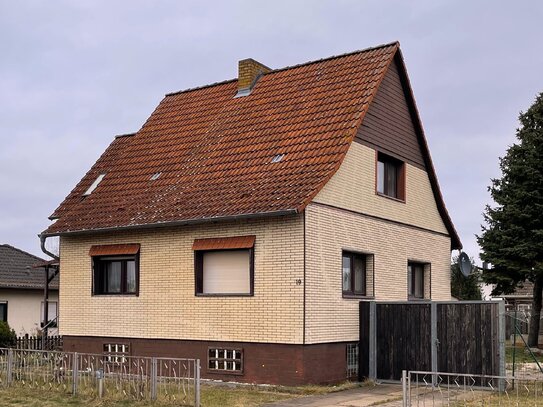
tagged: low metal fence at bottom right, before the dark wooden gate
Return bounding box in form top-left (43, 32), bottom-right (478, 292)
top-left (402, 371), bottom-right (543, 407)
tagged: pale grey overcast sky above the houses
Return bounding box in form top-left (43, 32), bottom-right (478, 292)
top-left (0, 0), bottom-right (543, 257)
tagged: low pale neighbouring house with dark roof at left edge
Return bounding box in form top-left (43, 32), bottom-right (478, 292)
top-left (0, 244), bottom-right (58, 336)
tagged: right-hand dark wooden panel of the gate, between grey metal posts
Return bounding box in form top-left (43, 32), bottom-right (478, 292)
top-left (437, 303), bottom-right (500, 376)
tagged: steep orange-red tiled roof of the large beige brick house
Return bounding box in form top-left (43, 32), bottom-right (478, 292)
top-left (44, 43), bottom-right (461, 248)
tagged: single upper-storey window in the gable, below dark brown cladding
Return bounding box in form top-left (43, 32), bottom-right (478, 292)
top-left (376, 153), bottom-right (405, 200)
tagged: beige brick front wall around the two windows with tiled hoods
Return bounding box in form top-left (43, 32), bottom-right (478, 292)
top-left (60, 215), bottom-right (304, 343)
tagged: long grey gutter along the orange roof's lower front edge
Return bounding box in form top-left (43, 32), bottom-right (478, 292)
top-left (39, 209), bottom-right (299, 239)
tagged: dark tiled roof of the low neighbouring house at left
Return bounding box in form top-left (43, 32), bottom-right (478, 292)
top-left (0, 244), bottom-right (58, 290)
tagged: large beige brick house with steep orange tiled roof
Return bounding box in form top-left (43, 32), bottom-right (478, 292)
top-left (41, 43), bottom-right (461, 384)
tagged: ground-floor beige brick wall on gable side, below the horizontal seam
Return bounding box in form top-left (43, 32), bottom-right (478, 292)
top-left (306, 204), bottom-right (451, 343)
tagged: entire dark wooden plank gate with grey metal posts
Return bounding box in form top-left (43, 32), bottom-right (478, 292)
top-left (359, 301), bottom-right (505, 380)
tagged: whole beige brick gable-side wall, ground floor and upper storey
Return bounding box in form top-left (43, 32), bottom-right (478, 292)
top-left (306, 143), bottom-right (451, 343)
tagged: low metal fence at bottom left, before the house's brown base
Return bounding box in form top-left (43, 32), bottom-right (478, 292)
top-left (0, 348), bottom-right (200, 407)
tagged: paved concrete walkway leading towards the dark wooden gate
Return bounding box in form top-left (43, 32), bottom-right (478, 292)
top-left (263, 384), bottom-right (402, 407)
